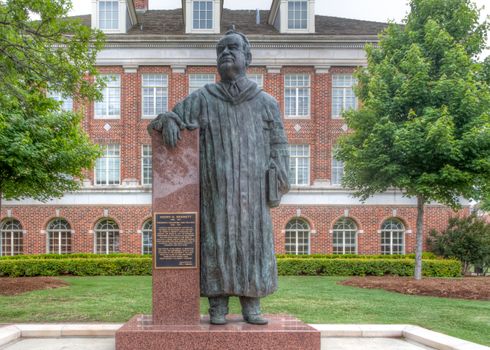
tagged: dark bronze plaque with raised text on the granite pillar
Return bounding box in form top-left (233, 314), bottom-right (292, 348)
top-left (153, 213), bottom-right (198, 269)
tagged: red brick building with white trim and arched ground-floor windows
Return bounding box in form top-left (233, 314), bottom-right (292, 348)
top-left (0, 0), bottom-right (468, 255)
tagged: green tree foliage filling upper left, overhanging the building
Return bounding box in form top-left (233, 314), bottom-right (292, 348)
top-left (0, 0), bottom-right (103, 213)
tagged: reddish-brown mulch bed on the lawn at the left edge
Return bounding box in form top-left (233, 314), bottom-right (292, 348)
top-left (0, 277), bottom-right (69, 295)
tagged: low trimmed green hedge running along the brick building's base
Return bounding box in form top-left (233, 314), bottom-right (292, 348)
top-left (0, 256), bottom-right (461, 277)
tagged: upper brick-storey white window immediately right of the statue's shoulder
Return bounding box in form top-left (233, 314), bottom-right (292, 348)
top-left (284, 74), bottom-right (310, 117)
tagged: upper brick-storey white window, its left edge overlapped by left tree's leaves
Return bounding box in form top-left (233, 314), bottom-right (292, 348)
top-left (95, 74), bottom-right (121, 119)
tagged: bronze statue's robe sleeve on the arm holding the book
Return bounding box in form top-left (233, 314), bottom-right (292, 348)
top-left (267, 101), bottom-right (290, 200)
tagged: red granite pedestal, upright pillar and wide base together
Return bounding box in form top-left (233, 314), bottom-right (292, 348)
top-left (116, 130), bottom-right (320, 350)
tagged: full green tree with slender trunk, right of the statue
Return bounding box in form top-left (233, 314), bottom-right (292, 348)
top-left (337, 0), bottom-right (490, 279)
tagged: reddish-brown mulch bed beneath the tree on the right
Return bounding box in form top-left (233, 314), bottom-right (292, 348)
top-left (339, 276), bottom-right (490, 300)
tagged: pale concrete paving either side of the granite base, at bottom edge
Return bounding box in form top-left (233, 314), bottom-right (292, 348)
top-left (0, 338), bottom-right (431, 350)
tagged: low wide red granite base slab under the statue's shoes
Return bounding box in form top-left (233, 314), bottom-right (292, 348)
top-left (116, 315), bottom-right (320, 350)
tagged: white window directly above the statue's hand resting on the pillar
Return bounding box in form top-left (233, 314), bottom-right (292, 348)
top-left (141, 74), bottom-right (168, 118)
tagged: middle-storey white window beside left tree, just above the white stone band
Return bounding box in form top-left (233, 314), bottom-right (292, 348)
top-left (95, 145), bottom-right (121, 185)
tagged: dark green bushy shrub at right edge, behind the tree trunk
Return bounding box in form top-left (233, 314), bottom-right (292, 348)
top-left (428, 215), bottom-right (490, 274)
